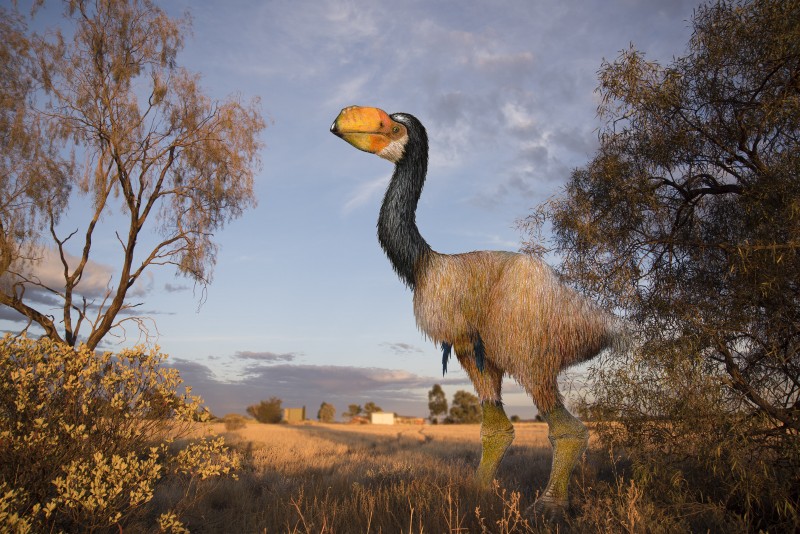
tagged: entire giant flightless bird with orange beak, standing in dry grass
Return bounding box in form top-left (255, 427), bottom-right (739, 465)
top-left (331, 106), bottom-right (619, 513)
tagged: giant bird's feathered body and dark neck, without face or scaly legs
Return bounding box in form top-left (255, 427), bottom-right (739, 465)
top-left (364, 108), bottom-right (616, 411)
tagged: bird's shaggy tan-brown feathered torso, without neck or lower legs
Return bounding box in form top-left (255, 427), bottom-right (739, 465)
top-left (414, 251), bottom-right (613, 411)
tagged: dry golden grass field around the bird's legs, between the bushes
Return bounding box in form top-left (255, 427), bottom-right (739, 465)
top-left (145, 422), bottom-right (791, 534)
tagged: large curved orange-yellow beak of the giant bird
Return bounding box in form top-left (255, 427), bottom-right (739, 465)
top-left (331, 106), bottom-right (392, 154)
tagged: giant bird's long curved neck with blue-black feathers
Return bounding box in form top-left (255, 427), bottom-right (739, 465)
top-left (378, 115), bottom-right (431, 289)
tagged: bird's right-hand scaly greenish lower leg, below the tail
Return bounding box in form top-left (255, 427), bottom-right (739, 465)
top-left (535, 403), bottom-right (589, 518)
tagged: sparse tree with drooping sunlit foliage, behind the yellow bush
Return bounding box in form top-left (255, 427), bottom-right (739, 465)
top-left (0, 0), bottom-right (265, 349)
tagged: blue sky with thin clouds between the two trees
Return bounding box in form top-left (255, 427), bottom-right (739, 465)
top-left (0, 0), bottom-right (698, 418)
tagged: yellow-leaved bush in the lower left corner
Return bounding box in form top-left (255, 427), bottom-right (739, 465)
top-left (0, 335), bottom-right (238, 532)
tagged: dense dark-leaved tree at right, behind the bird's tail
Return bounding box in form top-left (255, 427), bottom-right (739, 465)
top-left (525, 0), bottom-right (800, 530)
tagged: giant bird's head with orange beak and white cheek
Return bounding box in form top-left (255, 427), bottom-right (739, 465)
top-left (331, 106), bottom-right (408, 163)
